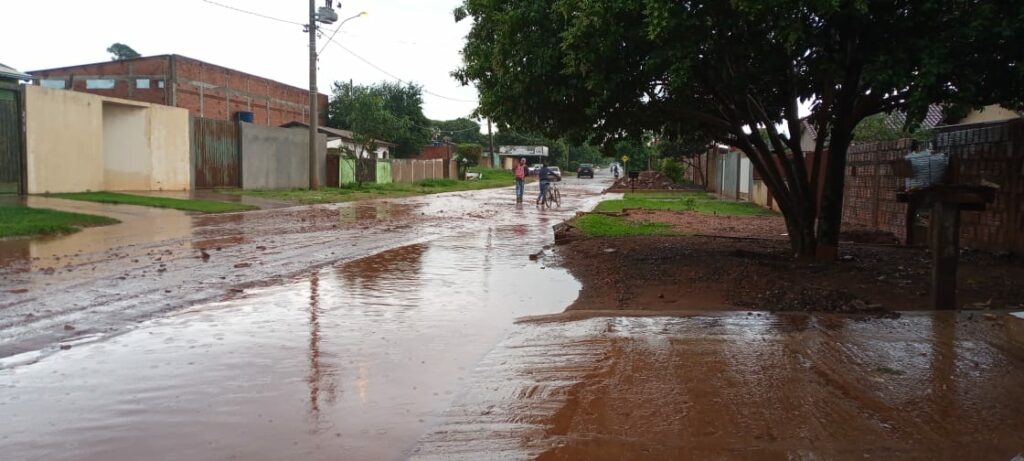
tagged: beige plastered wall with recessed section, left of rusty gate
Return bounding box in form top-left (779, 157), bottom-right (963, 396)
top-left (26, 86), bottom-right (190, 194)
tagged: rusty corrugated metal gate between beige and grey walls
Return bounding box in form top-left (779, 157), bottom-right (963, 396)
top-left (190, 117), bottom-right (242, 188)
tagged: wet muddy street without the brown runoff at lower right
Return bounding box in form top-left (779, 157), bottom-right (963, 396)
top-left (0, 176), bottom-right (607, 460)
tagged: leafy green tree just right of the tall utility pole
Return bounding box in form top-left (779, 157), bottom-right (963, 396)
top-left (327, 82), bottom-right (430, 158)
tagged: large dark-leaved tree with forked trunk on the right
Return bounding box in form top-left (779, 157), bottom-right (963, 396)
top-left (454, 0), bottom-right (1024, 259)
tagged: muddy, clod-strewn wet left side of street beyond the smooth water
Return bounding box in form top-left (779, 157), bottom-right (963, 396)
top-left (0, 180), bottom-right (602, 361)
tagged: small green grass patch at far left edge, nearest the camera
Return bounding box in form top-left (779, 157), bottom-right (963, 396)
top-left (0, 204), bottom-right (119, 238)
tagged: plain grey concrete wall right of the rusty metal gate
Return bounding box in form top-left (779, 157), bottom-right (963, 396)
top-left (240, 123), bottom-right (327, 188)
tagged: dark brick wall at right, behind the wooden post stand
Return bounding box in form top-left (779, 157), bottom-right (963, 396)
top-left (843, 120), bottom-right (1024, 251)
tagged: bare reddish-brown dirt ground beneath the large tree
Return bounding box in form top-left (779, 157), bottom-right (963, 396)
top-left (557, 226), bottom-right (1024, 312)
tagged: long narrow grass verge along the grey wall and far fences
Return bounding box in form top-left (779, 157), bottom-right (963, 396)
top-left (232, 169), bottom-right (514, 204)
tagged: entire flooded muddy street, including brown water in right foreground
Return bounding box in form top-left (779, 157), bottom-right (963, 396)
top-left (0, 176), bottom-right (1024, 461)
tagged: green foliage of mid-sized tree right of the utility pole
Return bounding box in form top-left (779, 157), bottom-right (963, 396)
top-left (327, 82), bottom-right (430, 158)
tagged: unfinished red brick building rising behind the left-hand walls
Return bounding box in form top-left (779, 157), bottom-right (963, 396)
top-left (31, 54), bottom-right (328, 126)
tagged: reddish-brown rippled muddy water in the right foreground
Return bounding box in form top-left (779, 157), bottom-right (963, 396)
top-left (414, 313), bottom-right (1024, 460)
